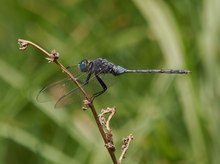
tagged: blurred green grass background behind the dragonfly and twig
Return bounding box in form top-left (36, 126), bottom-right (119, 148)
top-left (0, 0), bottom-right (220, 164)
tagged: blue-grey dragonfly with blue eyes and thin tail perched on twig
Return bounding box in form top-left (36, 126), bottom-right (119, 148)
top-left (37, 58), bottom-right (191, 107)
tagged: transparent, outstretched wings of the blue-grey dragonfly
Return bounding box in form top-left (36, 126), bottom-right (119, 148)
top-left (37, 66), bottom-right (118, 108)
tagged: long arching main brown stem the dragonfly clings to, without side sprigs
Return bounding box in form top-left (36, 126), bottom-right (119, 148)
top-left (18, 39), bottom-right (117, 164)
